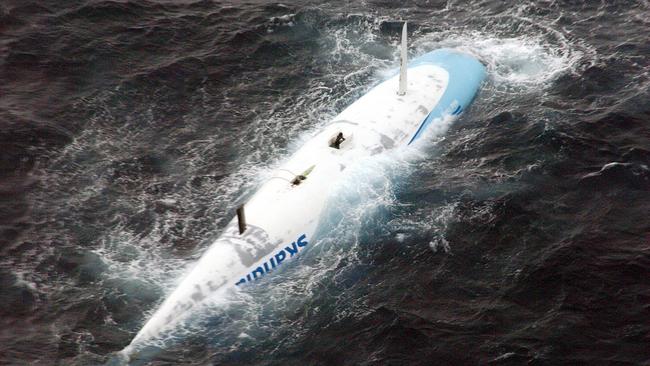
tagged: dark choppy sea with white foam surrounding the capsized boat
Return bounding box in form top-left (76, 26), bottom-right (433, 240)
top-left (0, 0), bottom-right (650, 365)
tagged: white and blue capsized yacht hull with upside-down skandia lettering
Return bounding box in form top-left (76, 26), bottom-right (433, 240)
top-left (124, 50), bottom-right (485, 352)
